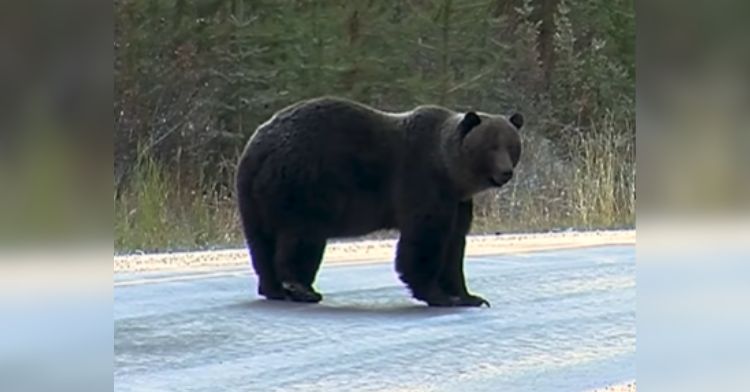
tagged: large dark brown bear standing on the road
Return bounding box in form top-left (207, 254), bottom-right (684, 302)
top-left (235, 96), bottom-right (524, 307)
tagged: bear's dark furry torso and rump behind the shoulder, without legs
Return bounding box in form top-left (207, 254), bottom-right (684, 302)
top-left (242, 98), bottom-right (424, 235)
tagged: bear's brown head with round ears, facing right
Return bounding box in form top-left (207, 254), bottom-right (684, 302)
top-left (452, 112), bottom-right (524, 197)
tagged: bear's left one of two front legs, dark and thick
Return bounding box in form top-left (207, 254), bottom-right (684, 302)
top-left (396, 208), bottom-right (455, 306)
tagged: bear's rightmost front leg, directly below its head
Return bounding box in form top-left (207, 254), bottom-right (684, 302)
top-left (440, 200), bottom-right (490, 307)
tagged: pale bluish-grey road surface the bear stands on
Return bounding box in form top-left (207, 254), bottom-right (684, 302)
top-left (114, 246), bottom-right (635, 392)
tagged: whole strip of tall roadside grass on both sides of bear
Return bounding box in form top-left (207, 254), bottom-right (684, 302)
top-left (115, 122), bottom-right (635, 252)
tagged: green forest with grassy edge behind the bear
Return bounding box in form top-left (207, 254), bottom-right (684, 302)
top-left (114, 0), bottom-right (635, 253)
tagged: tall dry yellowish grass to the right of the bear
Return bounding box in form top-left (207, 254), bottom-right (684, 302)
top-left (474, 115), bottom-right (635, 232)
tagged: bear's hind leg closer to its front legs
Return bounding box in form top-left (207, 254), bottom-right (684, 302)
top-left (275, 232), bottom-right (326, 303)
